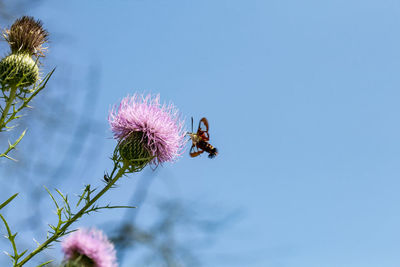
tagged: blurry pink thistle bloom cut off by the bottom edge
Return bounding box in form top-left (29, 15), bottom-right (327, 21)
top-left (61, 229), bottom-right (118, 267)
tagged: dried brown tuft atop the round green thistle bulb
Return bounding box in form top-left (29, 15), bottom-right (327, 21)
top-left (3, 16), bottom-right (49, 56)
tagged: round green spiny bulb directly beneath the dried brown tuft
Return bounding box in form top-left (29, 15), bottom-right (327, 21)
top-left (0, 53), bottom-right (39, 87)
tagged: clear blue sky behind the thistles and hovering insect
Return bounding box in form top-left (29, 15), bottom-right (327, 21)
top-left (7, 0), bottom-right (400, 267)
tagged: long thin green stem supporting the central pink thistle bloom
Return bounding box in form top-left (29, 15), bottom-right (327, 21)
top-left (16, 165), bottom-right (127, 267)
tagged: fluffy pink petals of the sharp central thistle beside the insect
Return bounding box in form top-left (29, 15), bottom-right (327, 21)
top-left (108, 94), bottom-right (187, 164)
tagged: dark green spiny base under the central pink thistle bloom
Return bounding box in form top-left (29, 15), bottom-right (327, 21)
top-left (118, 132), bottom-right (152, 168)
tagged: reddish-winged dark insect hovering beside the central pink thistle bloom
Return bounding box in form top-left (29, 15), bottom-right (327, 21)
top-left (188, 117), bottom-right (218, 159)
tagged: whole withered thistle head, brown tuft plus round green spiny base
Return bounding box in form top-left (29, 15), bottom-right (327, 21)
top-left (0, 16), bottom-right (48, 87)
